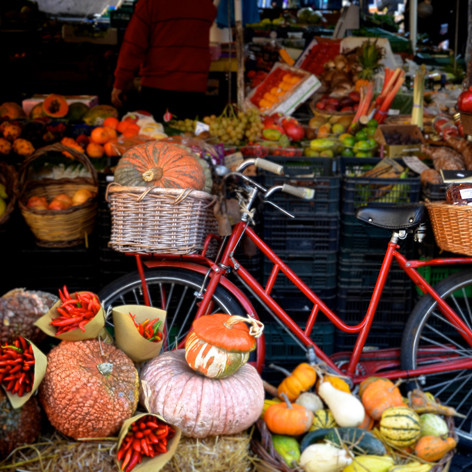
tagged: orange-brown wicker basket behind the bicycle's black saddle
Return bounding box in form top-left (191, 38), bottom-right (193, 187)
top-left (426, 201), bottom-right (472, 256)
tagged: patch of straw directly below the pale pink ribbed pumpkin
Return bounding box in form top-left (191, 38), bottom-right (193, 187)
top-left (162, 433), bottom-right (254, 472)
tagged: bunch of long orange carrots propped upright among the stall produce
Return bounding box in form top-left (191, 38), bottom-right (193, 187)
top-left (349, 67), bottom-right (405, 131)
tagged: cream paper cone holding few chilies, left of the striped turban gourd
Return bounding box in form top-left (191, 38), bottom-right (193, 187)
top-left (113, 305), bottom-right (166, 362)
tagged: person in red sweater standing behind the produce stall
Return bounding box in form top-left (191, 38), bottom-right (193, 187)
top-left (111, 0), bottom-right (217, 121)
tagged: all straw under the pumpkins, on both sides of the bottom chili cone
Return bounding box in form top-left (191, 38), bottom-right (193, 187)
top-left (0, 432), bottom-right (254, 472)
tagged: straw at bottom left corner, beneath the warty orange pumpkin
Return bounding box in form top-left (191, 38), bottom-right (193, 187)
top-left (0, 433), bottom-right (118, 472)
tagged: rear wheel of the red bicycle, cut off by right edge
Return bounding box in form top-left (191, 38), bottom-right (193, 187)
top-left (401, 271), bottom-right (472, 447)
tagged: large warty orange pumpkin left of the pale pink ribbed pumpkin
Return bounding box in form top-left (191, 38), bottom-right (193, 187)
top-left (39, 339), bottom-right (139, 439)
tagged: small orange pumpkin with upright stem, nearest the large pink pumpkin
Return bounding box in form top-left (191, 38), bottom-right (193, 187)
top-left (264, 394), bottom-right (313, 436)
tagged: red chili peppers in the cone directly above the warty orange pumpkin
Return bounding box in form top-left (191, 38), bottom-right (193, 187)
top-left (50, 285), bottom-right (100, 334)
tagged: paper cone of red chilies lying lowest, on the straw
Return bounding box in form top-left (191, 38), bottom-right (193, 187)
top-left (116, 413), bottom-right (182, 472)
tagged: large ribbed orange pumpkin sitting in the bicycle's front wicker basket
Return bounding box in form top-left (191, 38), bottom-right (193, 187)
top-left (115, 141), bottom-right (205, 190)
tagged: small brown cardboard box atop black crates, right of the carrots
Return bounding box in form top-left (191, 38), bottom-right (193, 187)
top-left (374, 125), bottom-right (425, 157)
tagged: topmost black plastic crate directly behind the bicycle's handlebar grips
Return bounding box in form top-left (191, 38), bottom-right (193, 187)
top-left (259, 156), bottom-right (338, 177)
